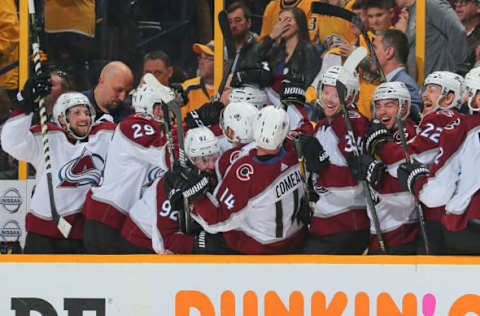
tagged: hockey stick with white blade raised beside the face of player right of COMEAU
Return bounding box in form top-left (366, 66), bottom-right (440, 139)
top-left (336, 47), bottom-right (387, 253)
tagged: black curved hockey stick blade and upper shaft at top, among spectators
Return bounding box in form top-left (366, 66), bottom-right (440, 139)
top-left (312, 1), bottom-right (387, 82)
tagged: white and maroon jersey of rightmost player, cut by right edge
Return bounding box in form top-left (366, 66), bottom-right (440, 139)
top-left (415, 115), bottom-right (480, 231)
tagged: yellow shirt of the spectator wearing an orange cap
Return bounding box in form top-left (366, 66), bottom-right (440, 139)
top-left (182, 77), bottom-right (215, 120)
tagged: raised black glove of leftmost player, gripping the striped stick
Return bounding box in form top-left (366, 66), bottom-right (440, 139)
top-left (15, 72), bottom-right (52, 114)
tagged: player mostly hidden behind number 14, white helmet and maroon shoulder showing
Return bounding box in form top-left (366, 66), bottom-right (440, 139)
top-left (215, 102), bottom-right (258, 181)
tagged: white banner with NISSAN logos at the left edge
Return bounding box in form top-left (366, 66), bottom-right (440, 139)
top-left (0, 180), bottom-right (35, 247)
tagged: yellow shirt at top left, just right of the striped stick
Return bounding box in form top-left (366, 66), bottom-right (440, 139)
top-left (45, 0), bottom-right (95, 37)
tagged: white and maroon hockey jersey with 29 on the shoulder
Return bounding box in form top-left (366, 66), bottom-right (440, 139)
top-left (83, 114), bottom-right (169, 229)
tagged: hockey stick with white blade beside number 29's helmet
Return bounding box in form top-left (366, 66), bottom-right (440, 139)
top-left (143, 73), bottom-right (192, 234)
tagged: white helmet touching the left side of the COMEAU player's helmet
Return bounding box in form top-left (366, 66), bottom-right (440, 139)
top-left (220, 102), bottom-right (258, 144)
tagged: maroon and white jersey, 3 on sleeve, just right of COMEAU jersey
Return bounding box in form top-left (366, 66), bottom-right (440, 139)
top-left (310, 111), bottom-right (369, 236)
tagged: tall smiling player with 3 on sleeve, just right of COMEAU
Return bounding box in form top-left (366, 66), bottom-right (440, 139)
top-left (301, 66), bottom-right (369, 254)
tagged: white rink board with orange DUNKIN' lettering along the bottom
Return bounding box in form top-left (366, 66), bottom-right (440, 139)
top-left (0, 255), bottom-right (480, 316)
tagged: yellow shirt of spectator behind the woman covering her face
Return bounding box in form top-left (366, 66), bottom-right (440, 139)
top-left (259, 0), bottom-right (317, 42)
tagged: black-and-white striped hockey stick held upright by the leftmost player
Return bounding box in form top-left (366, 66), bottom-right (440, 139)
top-left (28, 0), bottom-right (72, 238)
